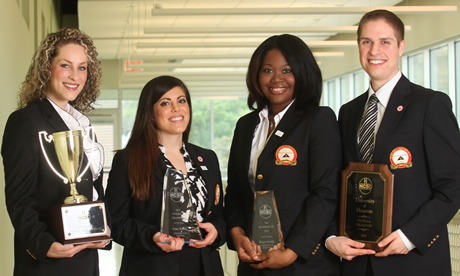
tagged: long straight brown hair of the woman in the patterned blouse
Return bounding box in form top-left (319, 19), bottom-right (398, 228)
top-left (126, 76), bottom-right (192, 201)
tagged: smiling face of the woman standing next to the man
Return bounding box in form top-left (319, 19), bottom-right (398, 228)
top-left (259, 49), bottom-right (295, 114)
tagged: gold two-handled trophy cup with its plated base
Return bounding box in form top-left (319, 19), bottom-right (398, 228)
top-left (38, 127), bottom-right (112, 244)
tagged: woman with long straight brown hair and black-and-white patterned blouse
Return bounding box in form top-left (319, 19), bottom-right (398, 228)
top-left (107, 76), bottom-right (225, 276)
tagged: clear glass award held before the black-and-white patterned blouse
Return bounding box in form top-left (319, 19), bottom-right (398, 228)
top-left (161, 168), bottom-right (202, 243)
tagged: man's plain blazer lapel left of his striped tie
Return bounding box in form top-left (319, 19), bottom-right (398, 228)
top-left (342, 91), bottom-right (368, 161)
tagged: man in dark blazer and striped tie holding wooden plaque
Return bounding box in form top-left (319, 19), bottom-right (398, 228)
top-left (326, 10), bottom-right (460, 276)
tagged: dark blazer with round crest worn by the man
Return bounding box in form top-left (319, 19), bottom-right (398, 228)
top-left (339, 76), bottom-right (460, 276)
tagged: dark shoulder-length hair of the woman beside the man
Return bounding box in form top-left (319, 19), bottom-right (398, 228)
top-left (246, 34), bottom-right (323, 110)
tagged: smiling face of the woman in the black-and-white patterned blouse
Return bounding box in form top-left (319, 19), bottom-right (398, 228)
top-left (153, 86), bottom-right (190, 139)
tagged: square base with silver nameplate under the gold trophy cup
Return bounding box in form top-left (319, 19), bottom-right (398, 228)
top-left (50, 200), bottom-right (112, 244)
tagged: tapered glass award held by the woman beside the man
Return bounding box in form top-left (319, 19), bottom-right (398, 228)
top-left (250, 191), bottom-right (284, 255)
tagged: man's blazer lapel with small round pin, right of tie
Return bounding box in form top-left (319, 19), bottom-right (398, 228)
top-left (374, 76), bottom-right (411, 163)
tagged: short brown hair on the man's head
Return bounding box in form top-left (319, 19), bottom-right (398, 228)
top-left (358, 10), bottom-right (404, 45)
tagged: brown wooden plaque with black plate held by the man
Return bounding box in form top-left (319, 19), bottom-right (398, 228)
top-left (340, 162), bottom-right (394, 252)
